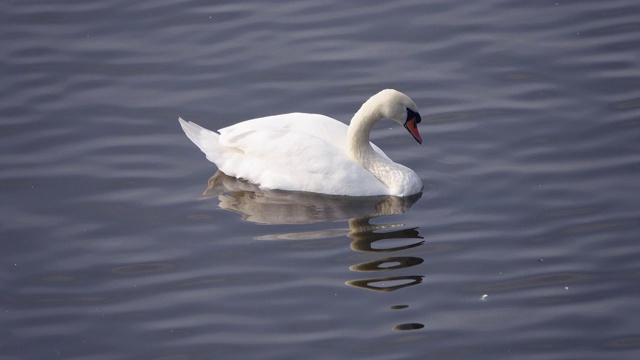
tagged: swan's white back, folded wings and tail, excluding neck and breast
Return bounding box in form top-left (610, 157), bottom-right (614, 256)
top-left (180, 113), bottom-right (388, 196)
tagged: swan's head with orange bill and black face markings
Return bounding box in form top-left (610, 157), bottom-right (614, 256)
top-left (374, 89), bottom-right (422, 144)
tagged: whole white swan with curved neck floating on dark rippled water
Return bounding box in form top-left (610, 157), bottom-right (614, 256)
top-left (178, 89), bottom-right (423, 197)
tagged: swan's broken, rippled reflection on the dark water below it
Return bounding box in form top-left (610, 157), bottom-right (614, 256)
top-left (201, 171), bottom-right (424, 330)
